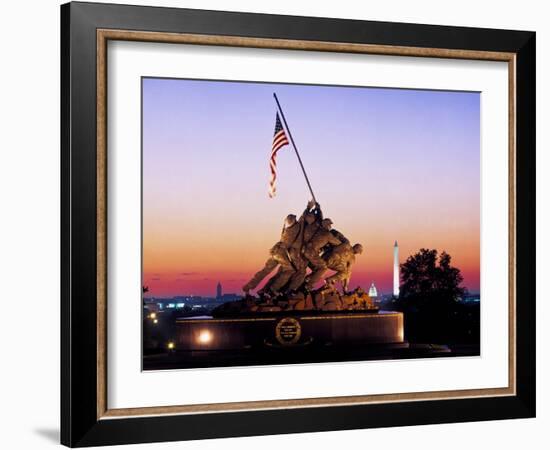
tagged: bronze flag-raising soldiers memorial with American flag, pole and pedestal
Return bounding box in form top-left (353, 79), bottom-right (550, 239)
top-left (175, 94), bottom-right (407, 362)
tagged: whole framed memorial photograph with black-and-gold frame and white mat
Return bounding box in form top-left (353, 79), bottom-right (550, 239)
top-left (61, 3), bottom-right (535, 447)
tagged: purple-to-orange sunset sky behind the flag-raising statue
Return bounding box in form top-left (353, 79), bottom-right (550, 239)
top-left (143, 78), bottom-right (480, 297)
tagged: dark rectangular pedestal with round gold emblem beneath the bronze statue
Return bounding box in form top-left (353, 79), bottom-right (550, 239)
top-left (175, 310), bottom-right (405, 351)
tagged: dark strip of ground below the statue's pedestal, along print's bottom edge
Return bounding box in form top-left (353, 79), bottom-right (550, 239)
top-left (143, 343), bottom-right (480, 370)
